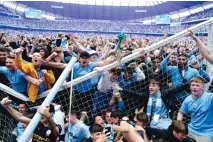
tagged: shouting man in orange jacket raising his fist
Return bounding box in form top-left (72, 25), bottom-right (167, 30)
top-left (15, 48), bottom-right (55, 102)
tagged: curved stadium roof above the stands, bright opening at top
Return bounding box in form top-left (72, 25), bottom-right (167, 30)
top-left (13, 0), bottom-right (206, 21)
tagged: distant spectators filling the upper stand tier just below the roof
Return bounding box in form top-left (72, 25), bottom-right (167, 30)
top-left (0, 17), bottom-right (205, 34)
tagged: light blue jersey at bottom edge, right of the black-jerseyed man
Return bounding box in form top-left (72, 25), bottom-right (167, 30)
top-left (65, 121), bottom-right (90, 142)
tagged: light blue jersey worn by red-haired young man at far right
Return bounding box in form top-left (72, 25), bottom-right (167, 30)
top-left (180, 92), bottom-right (213, 138)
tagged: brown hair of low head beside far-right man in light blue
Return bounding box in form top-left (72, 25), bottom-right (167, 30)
top-left (172, 120), bottom-right (188, 135)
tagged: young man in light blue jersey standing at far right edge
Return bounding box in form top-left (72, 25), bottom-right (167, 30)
top-left (177, 77), bottom-right (213, 142)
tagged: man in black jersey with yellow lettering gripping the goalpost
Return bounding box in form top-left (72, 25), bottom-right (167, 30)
top-left (1, 98), bottom-right (61, 142)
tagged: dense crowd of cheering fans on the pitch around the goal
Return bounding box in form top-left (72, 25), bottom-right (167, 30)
top-left (0, 29), bottom-right (213, 142)
